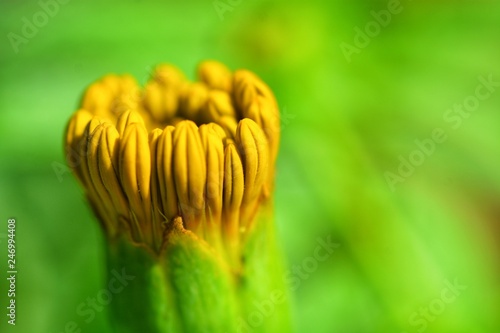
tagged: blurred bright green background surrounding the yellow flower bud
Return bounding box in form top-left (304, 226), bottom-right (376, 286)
top-left (0, 0), bottom-right (500, 333)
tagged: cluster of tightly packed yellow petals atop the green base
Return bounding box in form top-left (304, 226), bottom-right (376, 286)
top-left (65, 61), bottom-right (279, 260)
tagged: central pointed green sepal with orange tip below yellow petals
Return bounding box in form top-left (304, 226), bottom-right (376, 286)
top-left (162, 219), bottom-right (238, 333)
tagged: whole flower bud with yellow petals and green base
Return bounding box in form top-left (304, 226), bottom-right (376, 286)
top-left (65, 61), bottom-right (289, 333)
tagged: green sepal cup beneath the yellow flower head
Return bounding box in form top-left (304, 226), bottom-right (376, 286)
top-left (108, 214), bottom-right (291, 333)
